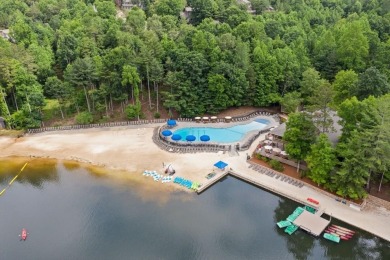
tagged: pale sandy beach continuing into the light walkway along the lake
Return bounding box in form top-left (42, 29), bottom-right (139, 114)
top-left (0, 125), bottom-right (390, 241)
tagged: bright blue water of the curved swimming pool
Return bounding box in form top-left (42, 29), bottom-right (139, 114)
top-left (173, 119), bottom-right (270, 143)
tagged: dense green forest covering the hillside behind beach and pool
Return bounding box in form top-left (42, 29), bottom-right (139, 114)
top-left (0, 0), bottom-right (390, 198)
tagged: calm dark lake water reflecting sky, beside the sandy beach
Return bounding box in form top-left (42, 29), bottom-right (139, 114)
top-left (0, 159), bottom-right (390, 260)
